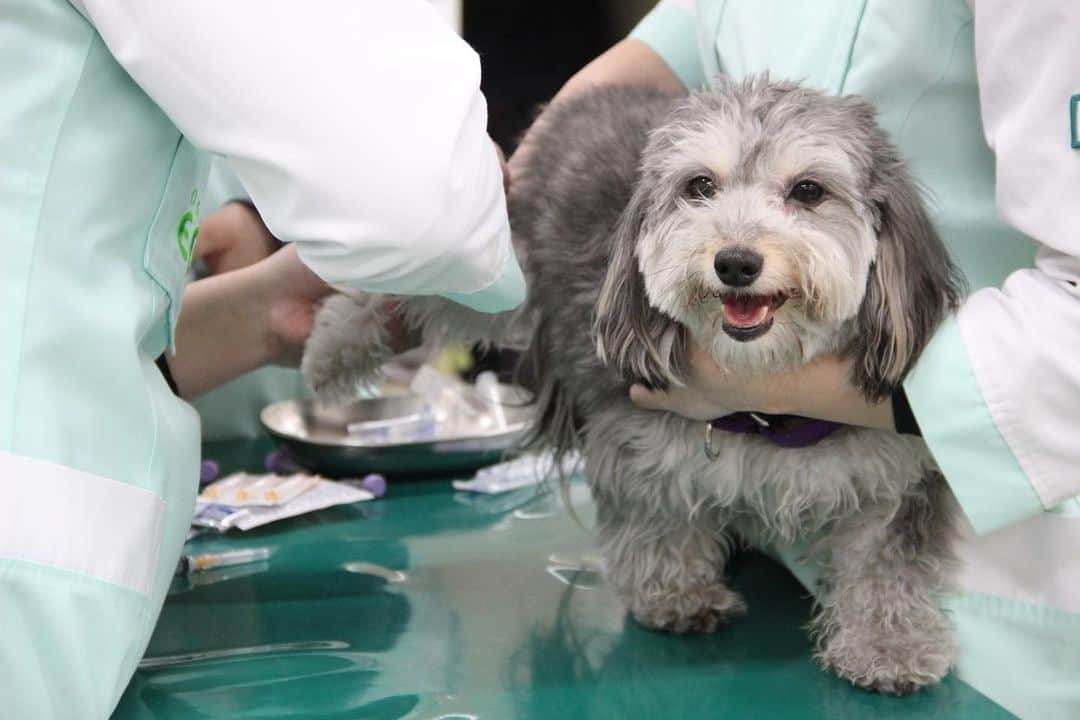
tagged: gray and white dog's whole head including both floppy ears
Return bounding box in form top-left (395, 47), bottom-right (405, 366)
top-left (597, 79), bottom-right (957, 396)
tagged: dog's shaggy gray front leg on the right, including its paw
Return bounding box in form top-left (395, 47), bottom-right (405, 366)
top-left (812, 475), bottom-right (957, 695)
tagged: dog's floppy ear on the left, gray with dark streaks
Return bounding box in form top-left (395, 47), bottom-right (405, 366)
top-left (593, 182), bottom-right (686, 389)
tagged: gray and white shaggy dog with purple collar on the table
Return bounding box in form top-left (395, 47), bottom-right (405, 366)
top-left (302, 78), bottom-right (961, 694)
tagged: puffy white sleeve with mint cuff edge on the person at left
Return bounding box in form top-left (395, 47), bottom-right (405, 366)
top-left (80, 0), bottom-right (524, 311)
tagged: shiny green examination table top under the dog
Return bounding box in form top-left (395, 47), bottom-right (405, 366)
top-left (113, 440), bottom-right (1012, 720)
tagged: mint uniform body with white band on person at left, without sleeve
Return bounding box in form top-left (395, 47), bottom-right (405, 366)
top-left (0, 1), bottom-right (207, 718)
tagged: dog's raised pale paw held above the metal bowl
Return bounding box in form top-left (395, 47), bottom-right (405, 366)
top-left (300, 294), bottom-right (392, 404)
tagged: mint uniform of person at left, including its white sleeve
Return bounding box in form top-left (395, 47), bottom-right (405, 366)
top-left (0, 0), bottom-right (524, 720)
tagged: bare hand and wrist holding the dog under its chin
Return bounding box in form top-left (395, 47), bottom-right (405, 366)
top-left (630, 342), bottom-right (895, 430)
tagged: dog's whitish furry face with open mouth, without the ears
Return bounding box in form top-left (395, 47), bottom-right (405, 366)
top-left (636, 87), bottom-right (878, 368)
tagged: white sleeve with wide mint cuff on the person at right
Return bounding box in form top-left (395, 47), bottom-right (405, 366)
top-left (905, 0), bottom-right (1080, 532)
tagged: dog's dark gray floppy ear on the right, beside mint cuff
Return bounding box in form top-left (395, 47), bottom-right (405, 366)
top-left (853, 156), bottom-right (963, 400)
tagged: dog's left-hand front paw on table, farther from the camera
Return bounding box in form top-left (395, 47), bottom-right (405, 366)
top-left (630, 583), bottom-right (746, 635)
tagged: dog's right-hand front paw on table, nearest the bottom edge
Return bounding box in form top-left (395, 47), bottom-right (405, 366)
top-left (818, 619), bottom-right (956, 695)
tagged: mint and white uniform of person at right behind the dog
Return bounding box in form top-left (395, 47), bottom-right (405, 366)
top-left (632, 0), bottom-right (1080, 718)
